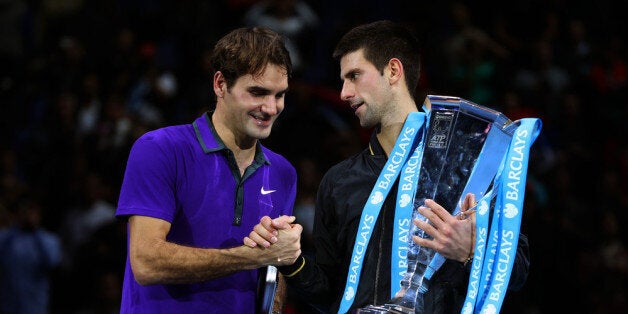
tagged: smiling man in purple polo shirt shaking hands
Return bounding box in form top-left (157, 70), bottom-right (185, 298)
top-left (116, 28), bottom-right (302, 313)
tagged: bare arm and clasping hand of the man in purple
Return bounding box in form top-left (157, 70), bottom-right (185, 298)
top-left (129, 216), bottom-right (302, 285)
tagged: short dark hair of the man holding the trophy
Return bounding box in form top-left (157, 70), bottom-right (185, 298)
top-left (333, 20), bottom-right (421, 99)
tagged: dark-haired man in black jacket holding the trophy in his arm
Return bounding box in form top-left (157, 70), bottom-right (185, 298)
top-left (244, 21), bottom-right (529, 313)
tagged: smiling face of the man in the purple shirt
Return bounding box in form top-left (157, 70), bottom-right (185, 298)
top-left (223, 64), bottom-right (288, 141)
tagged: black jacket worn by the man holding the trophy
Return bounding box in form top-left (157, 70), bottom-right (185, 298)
top-left (280, 134), bottom-right (529, 313)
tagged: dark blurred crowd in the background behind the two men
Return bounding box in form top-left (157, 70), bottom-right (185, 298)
top-left (0, 0), bottom-right (628, 314)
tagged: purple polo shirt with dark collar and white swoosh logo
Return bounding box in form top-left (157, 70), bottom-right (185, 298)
top-left (116, 113), bottom-right (296, 313)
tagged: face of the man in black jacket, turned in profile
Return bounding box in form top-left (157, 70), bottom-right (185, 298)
top-left (340, 49), bottom-right (392, 128)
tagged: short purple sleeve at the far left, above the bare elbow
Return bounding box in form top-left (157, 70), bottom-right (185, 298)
top-left (116, 133), bottom-right (176, 222)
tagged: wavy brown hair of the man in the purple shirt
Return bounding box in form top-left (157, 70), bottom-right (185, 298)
top-left (211, 27), bottom-right (292, 88)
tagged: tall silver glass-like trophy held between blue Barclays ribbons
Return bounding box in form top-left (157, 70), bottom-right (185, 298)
top-left (357, 95), bottom-right (516, 314)
